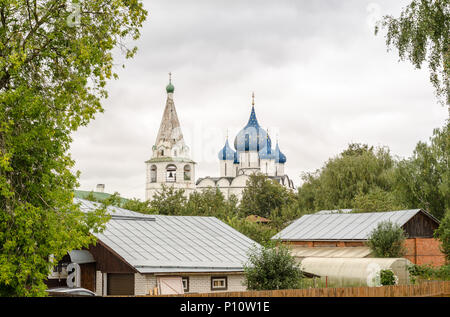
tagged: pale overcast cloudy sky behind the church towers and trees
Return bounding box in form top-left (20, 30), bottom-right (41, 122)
top-left (71, 0), bottom-right (447, 199)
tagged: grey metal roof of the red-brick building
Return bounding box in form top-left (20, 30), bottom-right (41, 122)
top-left (272, 209), bottom-right (420, 240)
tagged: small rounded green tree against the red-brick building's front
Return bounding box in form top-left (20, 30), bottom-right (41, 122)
top-left (367, 221), bottom-right (406, 258)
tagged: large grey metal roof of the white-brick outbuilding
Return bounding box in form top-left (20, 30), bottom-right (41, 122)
top-left (75, 199), bottom-right (259, 273)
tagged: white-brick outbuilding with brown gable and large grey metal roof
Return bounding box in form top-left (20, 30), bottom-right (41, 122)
top-left (48, 199), bottom-right (258, 296)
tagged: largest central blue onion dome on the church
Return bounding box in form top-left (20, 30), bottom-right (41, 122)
top-left (234, 107), bottom-right (267, 152)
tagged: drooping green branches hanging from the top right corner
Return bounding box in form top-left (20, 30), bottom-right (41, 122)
top-left (375, 0), bottom-right (450, 105)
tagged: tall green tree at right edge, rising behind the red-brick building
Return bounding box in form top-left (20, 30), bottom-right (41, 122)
top-left (394, 120), bottom-right (450, 219)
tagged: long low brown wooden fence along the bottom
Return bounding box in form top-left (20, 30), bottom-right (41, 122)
top-left (152, 281), bottom-right (450, 297)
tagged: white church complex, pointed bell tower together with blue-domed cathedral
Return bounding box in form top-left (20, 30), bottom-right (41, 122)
top-left (145, 75), bottom-right (294, 200)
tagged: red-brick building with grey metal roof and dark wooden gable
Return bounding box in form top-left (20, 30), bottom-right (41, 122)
top-left (273, 209), bottom-right (445, 266)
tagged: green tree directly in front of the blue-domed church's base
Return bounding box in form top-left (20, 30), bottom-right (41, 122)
top-left (240, 173), bottom-right (295, 218)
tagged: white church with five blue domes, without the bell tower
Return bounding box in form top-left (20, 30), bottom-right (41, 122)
top-left (196, 94), bottom-right (294, 198)
